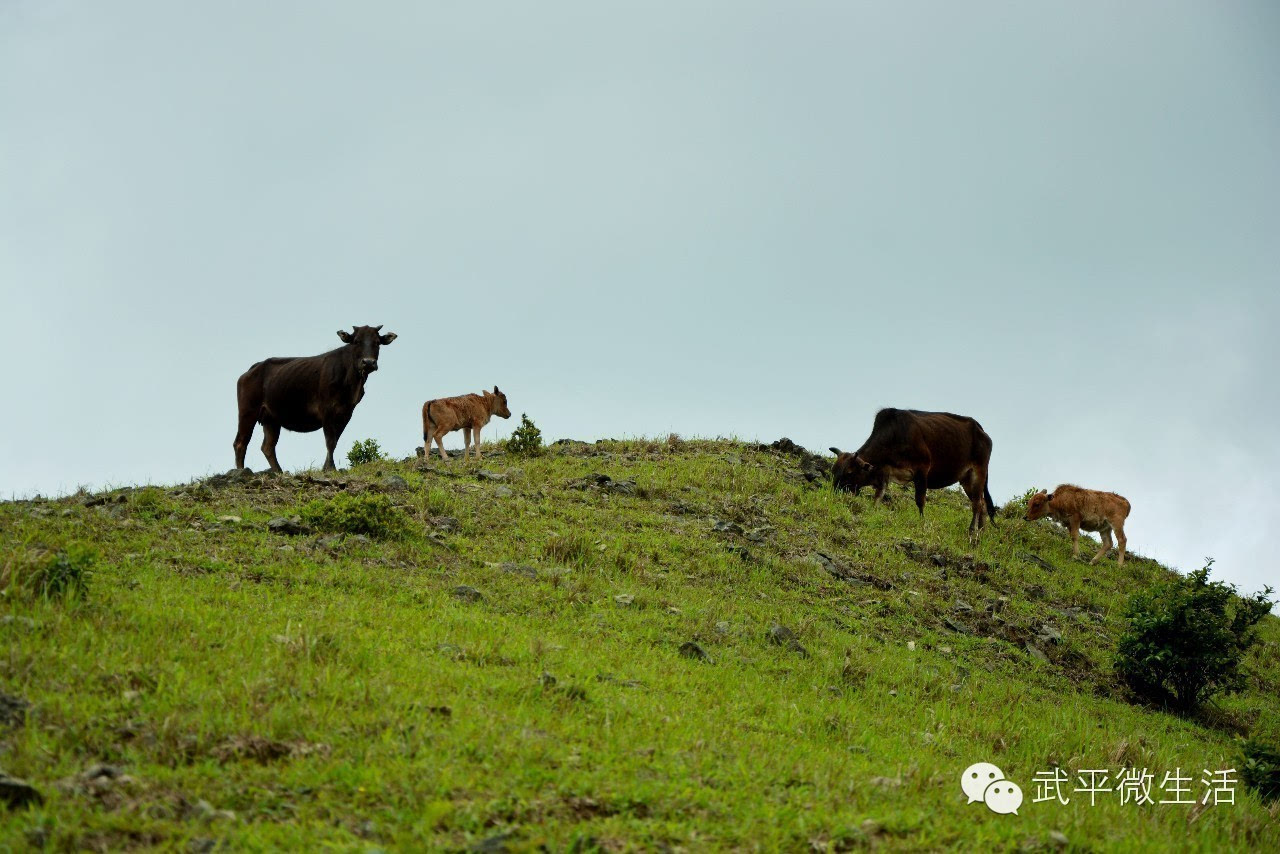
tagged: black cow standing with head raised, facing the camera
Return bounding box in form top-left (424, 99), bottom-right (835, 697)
top-left (234, 326), bottom-right (396, 471)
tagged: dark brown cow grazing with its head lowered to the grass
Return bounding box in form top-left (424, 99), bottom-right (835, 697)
top-left (831, 410), bottom-right (997, 536)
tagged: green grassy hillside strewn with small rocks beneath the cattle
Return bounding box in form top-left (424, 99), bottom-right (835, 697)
top-left (0, 440), bottom-right (1280, 851)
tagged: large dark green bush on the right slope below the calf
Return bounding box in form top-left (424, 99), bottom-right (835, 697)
top-left (1115, 560), bottom-right (1271, 713)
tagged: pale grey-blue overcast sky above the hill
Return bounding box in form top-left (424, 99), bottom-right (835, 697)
top-left (0, 0), bottom-right (1280, 601)
